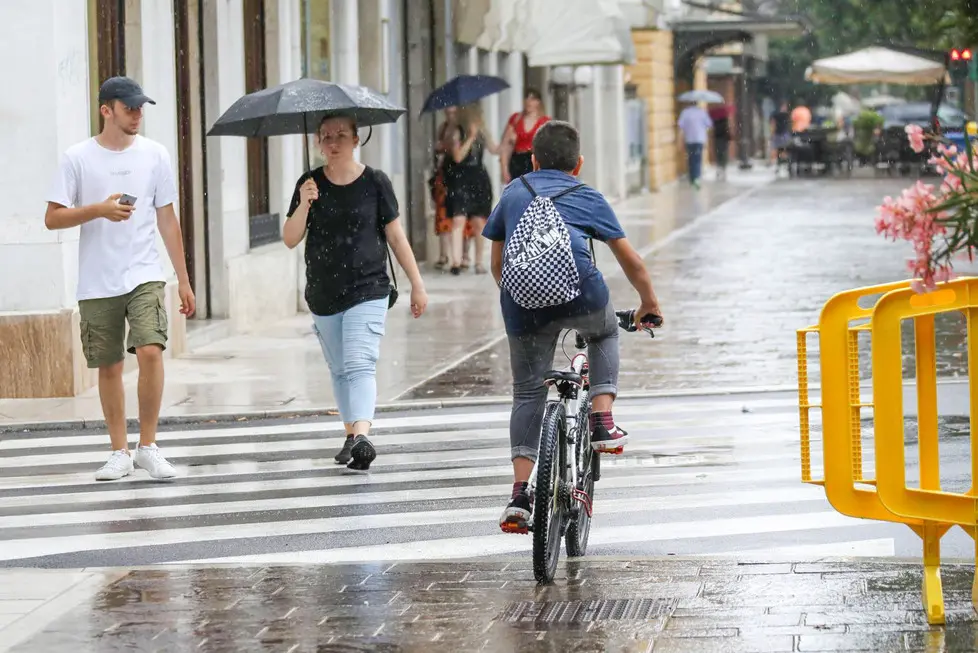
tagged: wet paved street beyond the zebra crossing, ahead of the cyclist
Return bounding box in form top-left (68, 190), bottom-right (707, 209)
top-left (405, 179), bottom-right (975, 399)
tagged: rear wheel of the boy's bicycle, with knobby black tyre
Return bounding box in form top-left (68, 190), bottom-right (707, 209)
top-left (533, 401), bottom-right (567, 583)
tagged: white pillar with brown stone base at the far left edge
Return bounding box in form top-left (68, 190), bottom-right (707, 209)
top-left (0, 0), bottom-right (94, 398)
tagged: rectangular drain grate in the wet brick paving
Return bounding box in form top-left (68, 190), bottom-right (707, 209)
top-left (502, 599), bottom-right (677, 624)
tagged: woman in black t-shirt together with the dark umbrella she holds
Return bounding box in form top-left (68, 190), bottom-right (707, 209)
top-left (208, 78), bottom-right (418, 470)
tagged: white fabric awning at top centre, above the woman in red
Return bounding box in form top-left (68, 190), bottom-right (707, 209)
top-left (455, 0), bottom-right (635, 66)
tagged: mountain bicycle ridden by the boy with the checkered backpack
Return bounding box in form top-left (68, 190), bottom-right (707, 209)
top-left (526, 310), bottom-right (662, 583)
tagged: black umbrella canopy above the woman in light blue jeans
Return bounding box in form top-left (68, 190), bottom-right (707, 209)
top-left (207, 78), bottom-right (406, 137)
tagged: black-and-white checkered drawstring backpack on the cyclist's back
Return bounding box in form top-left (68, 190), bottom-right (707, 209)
top-left (500, 177), bottom-right (584, 309)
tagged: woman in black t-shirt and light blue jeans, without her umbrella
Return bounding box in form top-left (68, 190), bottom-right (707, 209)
top-left (282, 112), bottom-right (428, 470)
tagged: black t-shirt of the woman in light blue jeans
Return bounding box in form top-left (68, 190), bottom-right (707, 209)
top-left (288, 166), bottom-right (398, 315)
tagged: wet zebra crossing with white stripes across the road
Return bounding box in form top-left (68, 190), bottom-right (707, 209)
top-left (0, 395), bottom-right (908, 567)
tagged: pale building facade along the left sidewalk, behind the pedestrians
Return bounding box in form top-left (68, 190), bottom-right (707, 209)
top-left (0, 0), bottom-right (629, 398)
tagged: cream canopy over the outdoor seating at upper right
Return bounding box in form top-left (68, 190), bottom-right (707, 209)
top-left (805, 47), bottom-right (947, 86)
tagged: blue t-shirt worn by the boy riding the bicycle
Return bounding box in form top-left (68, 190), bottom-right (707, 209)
top-left (482, 170), bottom-right (625, 335)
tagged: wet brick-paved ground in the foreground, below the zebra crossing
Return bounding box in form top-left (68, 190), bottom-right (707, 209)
top-left (13, 559), bottom-right (978, 653)
